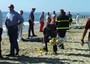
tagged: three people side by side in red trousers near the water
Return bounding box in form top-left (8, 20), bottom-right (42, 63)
top-left (39, 11), bottom-right (56, 32)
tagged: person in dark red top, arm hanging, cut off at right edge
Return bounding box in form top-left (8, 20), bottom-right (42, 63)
top-left (81, 18), bottom-right (90, 49)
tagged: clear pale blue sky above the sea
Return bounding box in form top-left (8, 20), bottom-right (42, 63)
top-left (0, 0), bottom-right (90, 12)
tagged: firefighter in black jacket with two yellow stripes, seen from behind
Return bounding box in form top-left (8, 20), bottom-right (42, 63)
top-left (56, 9), bottom-right (69, 49)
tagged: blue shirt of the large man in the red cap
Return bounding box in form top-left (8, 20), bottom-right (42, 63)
top-left (6, 10), bottom-right (24, 27)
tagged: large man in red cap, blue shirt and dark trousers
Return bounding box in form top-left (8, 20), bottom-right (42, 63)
top-left (5, 4), bottom-right (23, 56)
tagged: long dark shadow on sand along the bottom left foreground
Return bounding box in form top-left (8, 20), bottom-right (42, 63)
top-left (0, 56), bottom-right (68, 64)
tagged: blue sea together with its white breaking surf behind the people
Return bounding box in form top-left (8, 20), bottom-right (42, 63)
top-left (2, 12), bottom-right (90, 32)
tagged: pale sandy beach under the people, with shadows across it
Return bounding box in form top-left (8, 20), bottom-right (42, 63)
top-left (0, 19), bottom-right (90, 64)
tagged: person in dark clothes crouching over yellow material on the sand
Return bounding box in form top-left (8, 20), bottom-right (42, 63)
top-left (43, 24), bottom-right (57, 54)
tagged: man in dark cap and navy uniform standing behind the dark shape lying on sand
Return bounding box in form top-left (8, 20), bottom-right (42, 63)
top-left (28, 8), bottom-right (36, 38)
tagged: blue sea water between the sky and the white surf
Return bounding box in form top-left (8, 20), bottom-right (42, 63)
top-left (3, 12), bottom-right (90, 22)
